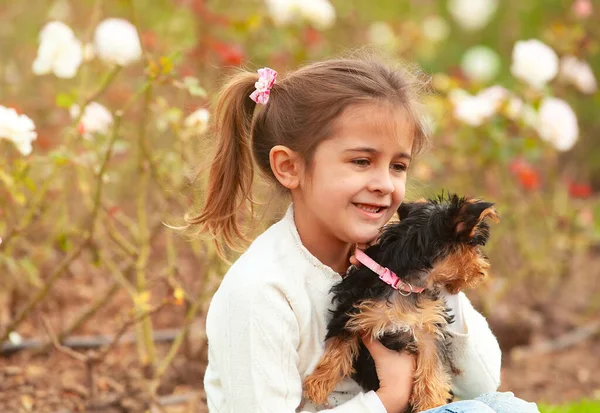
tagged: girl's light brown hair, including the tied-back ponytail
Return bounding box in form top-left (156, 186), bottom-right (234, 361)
top-left (185, 52), bottom-right (428, 251)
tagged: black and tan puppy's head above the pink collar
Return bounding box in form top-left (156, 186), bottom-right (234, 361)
top-left (378, 195), bottom-right (499, 294)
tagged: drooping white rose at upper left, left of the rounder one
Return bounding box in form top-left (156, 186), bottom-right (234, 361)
top-left (32, 21), bottom-right (83, 79)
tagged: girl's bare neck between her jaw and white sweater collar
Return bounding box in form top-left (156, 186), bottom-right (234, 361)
top-left (294, 208), bottom-right (352, 275)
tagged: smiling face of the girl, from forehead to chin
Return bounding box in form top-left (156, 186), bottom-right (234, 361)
top-left (292, 104), bottom-right (414, 253)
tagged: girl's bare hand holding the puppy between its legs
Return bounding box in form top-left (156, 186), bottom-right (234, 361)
top-left (363, 337), bottom-right (416, 413)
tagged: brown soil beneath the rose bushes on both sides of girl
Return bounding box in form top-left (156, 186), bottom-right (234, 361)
top-left (0, 249), bottom-right (600, 413)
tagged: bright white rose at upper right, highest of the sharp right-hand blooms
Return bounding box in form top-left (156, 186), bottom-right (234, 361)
top-left (510, 39), bottom-right (558, 89)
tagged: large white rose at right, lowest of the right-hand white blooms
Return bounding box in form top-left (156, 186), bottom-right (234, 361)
top-left (536, 97), bottom-right (579, 151)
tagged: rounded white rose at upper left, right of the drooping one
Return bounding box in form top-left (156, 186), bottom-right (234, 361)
top-left (94, 18), bottom-right (142, 66)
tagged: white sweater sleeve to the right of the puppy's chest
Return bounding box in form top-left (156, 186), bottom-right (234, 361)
top-left (451, 292), bottom-right (502, 399)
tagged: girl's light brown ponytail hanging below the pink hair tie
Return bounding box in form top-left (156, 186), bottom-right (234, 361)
top-left (185, 72), bottom-right (258, 256)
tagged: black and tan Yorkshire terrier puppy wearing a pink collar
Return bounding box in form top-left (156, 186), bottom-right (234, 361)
top-left (303, 195), bottom-right (498, 412)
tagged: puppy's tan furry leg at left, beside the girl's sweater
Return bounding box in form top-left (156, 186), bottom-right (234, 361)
top-left (303, 335), bottom-right (359, 404)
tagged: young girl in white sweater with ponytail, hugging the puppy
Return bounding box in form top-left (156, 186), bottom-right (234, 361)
top-left (188, 57), bottom-right (538, 413)
